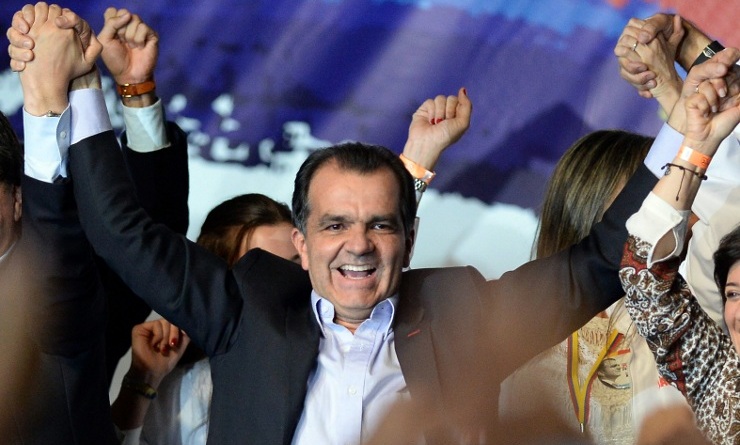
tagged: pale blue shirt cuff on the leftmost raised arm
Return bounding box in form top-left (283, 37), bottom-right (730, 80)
top-left (23, 106), bottom-right (71, 183)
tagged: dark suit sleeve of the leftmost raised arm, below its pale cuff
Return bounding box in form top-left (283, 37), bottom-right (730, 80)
top-left (3, 177), bottom-right (117, 445)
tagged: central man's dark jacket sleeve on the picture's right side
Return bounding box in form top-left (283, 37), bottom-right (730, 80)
top-left (482, 165), bottom-right (657, 376)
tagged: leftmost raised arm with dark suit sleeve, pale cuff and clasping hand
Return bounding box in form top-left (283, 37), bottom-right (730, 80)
top-left (11, 3), bottom-right (120, 443)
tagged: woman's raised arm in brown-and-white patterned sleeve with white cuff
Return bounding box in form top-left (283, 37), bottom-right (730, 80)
top-left (620, 49), bottom-right (740, 441)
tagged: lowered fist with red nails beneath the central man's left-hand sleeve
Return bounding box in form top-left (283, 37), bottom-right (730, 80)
top-left (129, 319), bottom-right (190, 388)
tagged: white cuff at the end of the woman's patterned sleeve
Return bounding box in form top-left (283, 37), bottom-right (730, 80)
top-left (627, 192), bottom-right (691, 267)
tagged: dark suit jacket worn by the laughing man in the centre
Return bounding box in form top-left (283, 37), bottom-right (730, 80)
top-left (69, 133), bottom-right (655, 444)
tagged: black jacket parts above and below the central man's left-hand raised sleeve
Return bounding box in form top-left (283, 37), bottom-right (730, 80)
top-left (97, 122), bottom-right (189, 381)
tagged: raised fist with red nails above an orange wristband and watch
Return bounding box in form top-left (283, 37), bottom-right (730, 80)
top-left (403, 88), bottom-right (473, 171)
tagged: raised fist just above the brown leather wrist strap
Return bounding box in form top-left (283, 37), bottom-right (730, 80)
top-left (98, 8), bottom-right (159, 85)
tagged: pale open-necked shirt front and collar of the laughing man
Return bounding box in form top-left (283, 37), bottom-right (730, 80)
top-left (293, 292), bottom-right (410, 445)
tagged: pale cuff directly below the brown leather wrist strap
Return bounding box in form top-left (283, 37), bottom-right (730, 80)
top-left (123, 99), bottom-right (170, 153)
